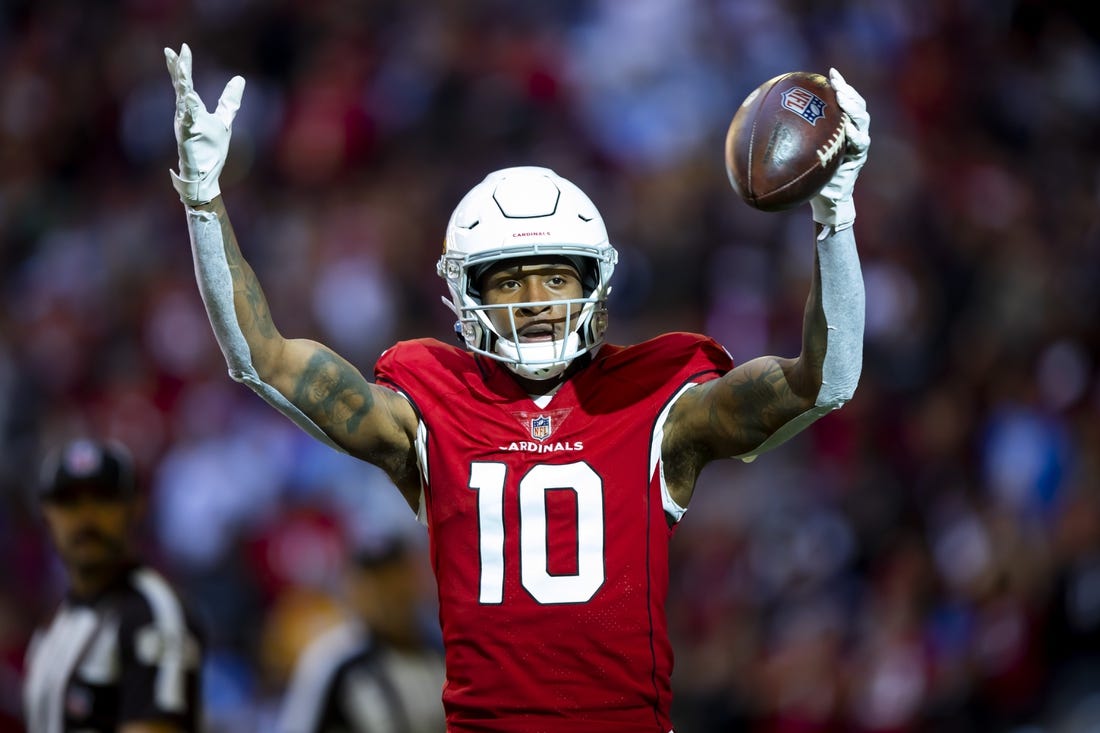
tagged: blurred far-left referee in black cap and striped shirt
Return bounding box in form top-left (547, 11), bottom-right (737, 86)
top-left (23, 439), bottom-right (202, 733)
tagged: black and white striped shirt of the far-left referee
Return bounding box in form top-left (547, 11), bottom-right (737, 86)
top-left (23, 567), bottom-right (202, 733)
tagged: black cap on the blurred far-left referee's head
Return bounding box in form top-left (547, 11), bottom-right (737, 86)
top-left (39, 438), bottom-right (136, 502)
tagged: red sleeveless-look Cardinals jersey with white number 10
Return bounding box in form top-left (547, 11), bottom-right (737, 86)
top-left (375, 333), bottom-right (733, 733)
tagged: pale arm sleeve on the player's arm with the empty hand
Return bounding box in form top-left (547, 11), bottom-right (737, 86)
top-left (186, 207), bottom-right (343, 451)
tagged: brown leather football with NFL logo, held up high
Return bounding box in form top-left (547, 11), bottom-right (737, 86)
top-left (726, 72), bottom-right (845, 211)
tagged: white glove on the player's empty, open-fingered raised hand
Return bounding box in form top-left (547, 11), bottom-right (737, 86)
top-left (164, 43), bottom-right (244, 206)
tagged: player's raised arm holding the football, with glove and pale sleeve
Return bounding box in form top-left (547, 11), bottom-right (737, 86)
top-left (663, 69), bottom-right (870, 473)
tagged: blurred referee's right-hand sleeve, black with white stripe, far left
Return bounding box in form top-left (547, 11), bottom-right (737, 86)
top-left (119, 570), bottom-right (202, 729)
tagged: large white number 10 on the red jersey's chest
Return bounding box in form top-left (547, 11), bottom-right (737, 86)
top-left (470, 462), bottom-right (604, 603)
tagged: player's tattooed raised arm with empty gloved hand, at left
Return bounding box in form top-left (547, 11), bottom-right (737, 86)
top-left (165, 44), bottom-right (419, 499)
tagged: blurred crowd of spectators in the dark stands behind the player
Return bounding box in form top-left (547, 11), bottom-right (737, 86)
top-left (0, 0), bottom-right (1100, 733)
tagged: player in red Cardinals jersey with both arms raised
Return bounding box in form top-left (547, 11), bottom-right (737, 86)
top-left (165, 45), bottom-right (869, 733)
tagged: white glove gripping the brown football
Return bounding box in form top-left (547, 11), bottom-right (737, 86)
top-left (810, 68), bottom-right (871, 236)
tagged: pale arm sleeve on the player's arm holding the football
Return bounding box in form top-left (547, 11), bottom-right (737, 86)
top-left (735, 227), bottom-right (866, 462)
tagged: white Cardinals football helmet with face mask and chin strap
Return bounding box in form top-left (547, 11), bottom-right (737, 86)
top-left (436, 166), bottom-right (618, 380)
